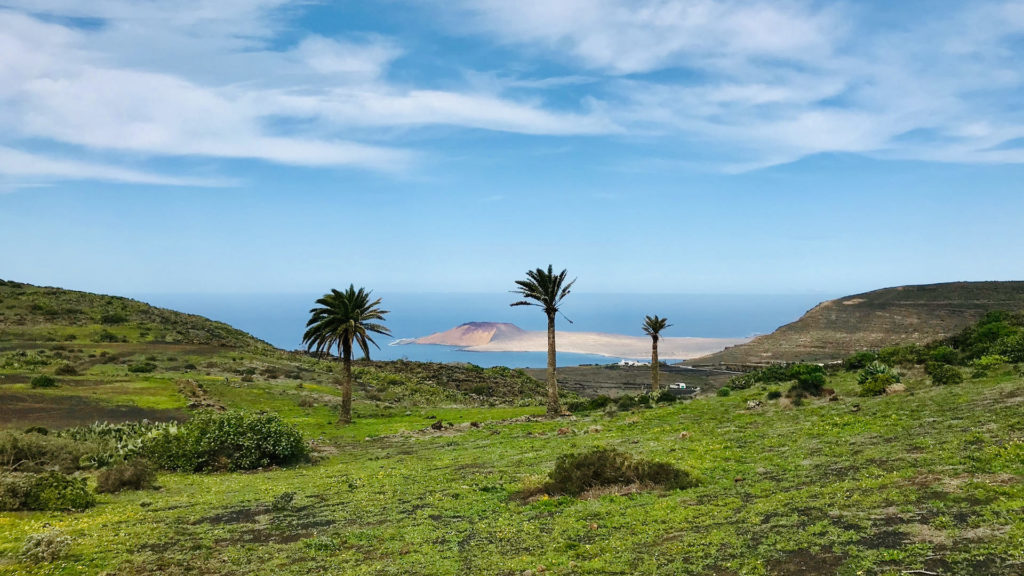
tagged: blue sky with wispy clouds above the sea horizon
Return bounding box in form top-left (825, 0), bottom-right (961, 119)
top-left (0, 0), bottom-right (1024, 294)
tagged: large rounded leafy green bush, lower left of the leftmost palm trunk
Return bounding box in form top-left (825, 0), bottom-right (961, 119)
top-left (142, 411), bottom-right (309, 471)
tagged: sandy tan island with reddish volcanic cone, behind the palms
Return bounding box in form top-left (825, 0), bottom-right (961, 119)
top-left (395, 322), bottom-right (751, 360)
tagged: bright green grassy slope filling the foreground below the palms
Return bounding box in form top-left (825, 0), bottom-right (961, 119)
top-left (0, 370), bottom-right (1024, 576)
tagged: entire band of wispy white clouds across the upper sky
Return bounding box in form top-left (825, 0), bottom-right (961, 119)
top-left (0, 0), bottom-right (1024, 183)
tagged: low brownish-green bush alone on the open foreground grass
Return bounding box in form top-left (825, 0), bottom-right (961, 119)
top-left (545, 448), bottom-right (696, 496)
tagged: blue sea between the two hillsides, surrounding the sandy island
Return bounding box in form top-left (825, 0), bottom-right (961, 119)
top-left (130, 292), bottom-right (834, 368)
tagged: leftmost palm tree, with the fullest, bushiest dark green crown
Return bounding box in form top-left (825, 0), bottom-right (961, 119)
top-left (302, 285), bottom-right (391, 424)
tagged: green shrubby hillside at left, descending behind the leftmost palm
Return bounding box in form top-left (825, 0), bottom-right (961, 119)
top-left (0, 281), bottom-right (544, 435)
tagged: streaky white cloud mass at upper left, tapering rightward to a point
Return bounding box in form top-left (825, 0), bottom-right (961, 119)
top-left (0, 0), bottom-right (614, 186)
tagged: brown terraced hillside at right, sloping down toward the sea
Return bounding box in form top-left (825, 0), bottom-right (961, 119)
top-left (687, 282), bottom-right (1024, 366)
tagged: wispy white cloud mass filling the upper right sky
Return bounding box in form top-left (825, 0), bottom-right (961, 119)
top-left (438, 0), bottom-right (1024, 170)
